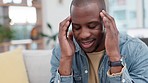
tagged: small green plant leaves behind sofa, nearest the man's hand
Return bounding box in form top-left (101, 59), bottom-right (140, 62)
top-left (40, 23), bottom-right (58, 44)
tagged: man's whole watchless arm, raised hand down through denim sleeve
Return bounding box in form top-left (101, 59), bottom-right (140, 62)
top-left (51, 16), bottom-right (75, 83)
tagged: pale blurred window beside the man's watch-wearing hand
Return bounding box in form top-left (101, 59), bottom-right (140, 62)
top-left (108, 0), bottom-right (137, 32)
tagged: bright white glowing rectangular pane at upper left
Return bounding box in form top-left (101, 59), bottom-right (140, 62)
top-left (9, 6), bottom-right (37, 24)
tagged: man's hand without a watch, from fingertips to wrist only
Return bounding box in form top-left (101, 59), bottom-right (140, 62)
top-left (58, 17), bottom-right (75, 57)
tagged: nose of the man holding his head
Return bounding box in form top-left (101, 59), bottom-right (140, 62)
top-left (79, 27), bottom-right (91, 39)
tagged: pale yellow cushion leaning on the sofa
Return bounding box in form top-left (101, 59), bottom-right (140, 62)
top-left (0, 48), bottom-right (29, 83)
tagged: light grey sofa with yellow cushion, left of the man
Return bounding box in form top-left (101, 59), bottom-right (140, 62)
top-left (0, 49), bottom-right (52, 83)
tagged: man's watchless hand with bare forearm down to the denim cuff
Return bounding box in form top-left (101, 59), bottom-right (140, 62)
top-left (58, 17), bottom-right (75, 75)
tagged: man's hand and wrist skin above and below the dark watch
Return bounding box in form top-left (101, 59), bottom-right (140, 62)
top-left (100, 10), bottom-right (122, 74)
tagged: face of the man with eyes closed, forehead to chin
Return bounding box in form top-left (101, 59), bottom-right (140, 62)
top-left (71, 3), bottom-right (103, 53)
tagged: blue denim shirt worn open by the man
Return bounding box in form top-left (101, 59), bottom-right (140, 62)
top-left (50, 35), bottom-right (148, 83)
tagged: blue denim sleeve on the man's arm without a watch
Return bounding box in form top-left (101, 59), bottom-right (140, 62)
top-left (50, 45), bottom-right (73, 83)
